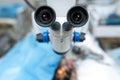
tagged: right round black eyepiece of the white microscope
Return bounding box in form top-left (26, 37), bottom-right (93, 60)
top-left (67, 6), bottom-right (89, 27)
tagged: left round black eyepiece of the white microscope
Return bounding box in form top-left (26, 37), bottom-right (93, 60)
top-left (34, 6), bottom-right (56, 27)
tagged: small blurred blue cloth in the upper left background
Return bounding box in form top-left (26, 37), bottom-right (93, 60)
top-left (0, 3), bottom-right (25, 18)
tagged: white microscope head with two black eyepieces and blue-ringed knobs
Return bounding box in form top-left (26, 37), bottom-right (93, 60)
top-left (27, 0), bottom-right (89, 54)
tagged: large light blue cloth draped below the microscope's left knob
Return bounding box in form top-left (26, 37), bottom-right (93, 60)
top-left (0, 34), bottom-right (62, 80)
